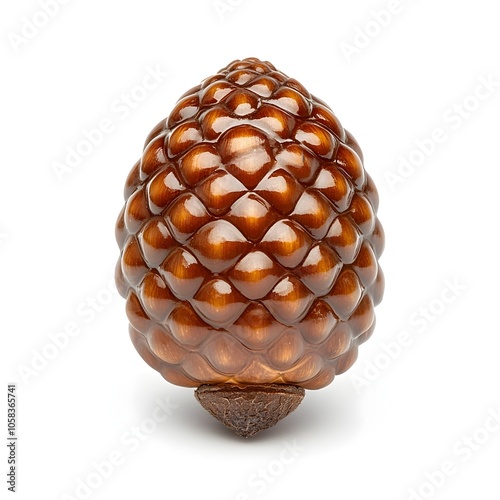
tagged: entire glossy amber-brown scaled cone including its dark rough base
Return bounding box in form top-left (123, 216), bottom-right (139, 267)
top-left (116, 58), bottom-right (384, 437)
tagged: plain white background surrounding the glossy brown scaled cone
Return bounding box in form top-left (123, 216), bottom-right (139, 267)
top-left (0, 0), bottom-right (500, 500)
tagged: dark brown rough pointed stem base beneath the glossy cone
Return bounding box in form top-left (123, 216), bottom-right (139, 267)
top-left (194, 384), bottom-right (305, 437)
